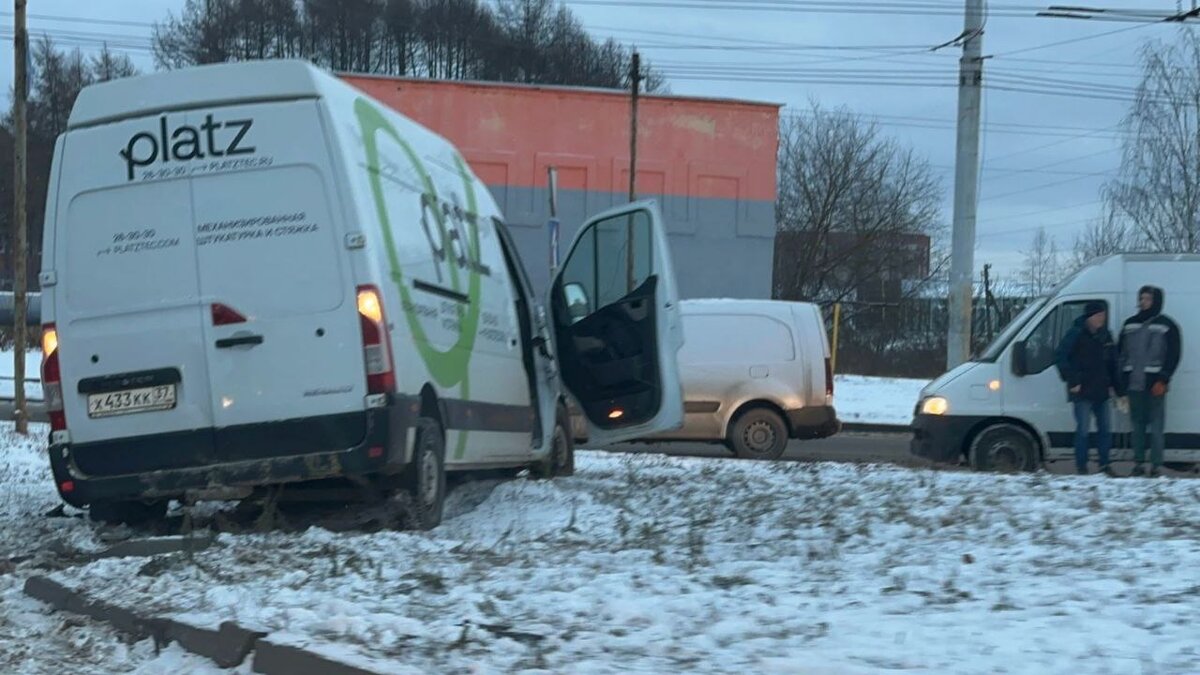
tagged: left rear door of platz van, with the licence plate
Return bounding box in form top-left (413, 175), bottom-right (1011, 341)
top-left (54, 115), bottom-right (212, 446)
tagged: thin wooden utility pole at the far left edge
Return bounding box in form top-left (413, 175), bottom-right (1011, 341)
top-left (12, 0), bottom-right (29, 436)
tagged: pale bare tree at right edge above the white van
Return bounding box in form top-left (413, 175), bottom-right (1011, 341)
top-left (1104, 30), bottom-right (1200, 252)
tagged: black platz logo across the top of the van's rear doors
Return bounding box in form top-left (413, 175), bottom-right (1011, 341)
top-left (120, 114), bottom-right (256, 180)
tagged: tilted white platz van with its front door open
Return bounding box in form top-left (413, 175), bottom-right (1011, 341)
top-left (41, 60), bottom-right (683, 527)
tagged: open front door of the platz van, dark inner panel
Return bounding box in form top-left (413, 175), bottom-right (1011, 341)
top-left (550, 196), bottom-right (683, 446)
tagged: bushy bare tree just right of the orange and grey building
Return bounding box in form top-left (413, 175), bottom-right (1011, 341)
top-left (775, 104), bottom-right (942, 301)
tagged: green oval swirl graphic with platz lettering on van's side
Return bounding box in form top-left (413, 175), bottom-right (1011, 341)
top-left (354, 98), bottom-right (490, 458)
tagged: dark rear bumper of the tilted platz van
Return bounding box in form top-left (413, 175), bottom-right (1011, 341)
top-left (49, 396), bottom-right (420, 507)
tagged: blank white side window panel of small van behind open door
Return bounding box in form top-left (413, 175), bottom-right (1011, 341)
top-left (679, 313), bottom-right (796, 364)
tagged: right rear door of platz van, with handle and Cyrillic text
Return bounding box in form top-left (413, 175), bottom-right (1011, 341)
top-left (192, 101), bottom-right (366, 449)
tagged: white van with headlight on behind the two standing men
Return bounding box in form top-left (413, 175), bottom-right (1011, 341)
top-left (912, 253), bottom-right (1200, 471)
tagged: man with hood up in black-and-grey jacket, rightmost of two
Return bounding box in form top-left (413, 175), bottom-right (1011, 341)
top-left (1118, 286), bottom-right (1181, 476)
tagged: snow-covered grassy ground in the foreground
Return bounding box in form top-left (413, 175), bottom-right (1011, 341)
top-left (0, 422), bottom-right (1200, 674)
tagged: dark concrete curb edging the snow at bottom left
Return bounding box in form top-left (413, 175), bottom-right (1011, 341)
top-left (25, 577), bottom-right (382, 675)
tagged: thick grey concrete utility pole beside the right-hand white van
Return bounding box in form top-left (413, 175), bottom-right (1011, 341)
top-left (946, 0), bottom-right (983, 370)
